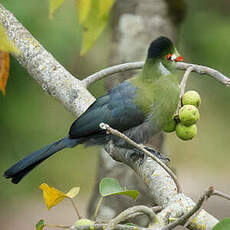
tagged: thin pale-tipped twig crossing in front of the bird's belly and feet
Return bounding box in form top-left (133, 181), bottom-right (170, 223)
top-left (100, 123), bottom-right (182, 193)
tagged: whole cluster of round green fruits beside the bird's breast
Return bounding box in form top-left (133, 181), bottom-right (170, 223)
top-left (163, 90), bottom-right (201, 140)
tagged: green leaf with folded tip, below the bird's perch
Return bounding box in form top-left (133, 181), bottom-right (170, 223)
top-left (100, 178), bottom-right (139, 200)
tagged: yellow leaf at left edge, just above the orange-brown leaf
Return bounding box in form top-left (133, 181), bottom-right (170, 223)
top-left (0, 24), bottom-right (19, 54)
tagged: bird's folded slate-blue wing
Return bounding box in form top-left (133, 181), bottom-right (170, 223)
top-left (69, 81), bottom-right (145, 138)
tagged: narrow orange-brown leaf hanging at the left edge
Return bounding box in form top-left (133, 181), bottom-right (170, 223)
top-left (0, 51), bottom-right (10, 95)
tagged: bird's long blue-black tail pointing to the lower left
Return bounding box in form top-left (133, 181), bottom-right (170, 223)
top-left (4, 137), bottom-right (79, 184)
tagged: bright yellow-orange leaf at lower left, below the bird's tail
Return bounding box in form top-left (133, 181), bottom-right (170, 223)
top-left (40, 183), bottom-right (67, 210)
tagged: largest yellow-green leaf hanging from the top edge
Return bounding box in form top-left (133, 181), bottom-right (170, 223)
top-left (80, 0), bottom-right (114, 55)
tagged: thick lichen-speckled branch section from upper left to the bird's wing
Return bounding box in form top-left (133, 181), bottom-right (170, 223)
top-left (0, 4), bottom-right (95, 116)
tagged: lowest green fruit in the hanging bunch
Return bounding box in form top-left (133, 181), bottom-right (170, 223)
top-left (176, 123), bottom-right (197, 141)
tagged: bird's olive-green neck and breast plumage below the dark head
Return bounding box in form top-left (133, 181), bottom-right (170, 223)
top-left (130, 56), bottom-right (180, 127)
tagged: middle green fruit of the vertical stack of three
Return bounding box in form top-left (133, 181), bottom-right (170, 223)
top-left (179, 105), bottom-right (200, 126)
